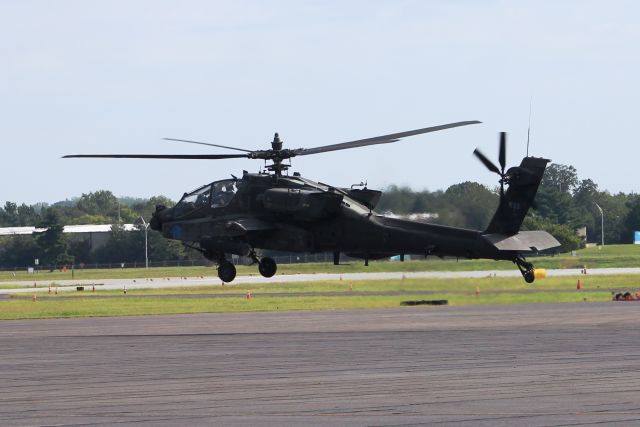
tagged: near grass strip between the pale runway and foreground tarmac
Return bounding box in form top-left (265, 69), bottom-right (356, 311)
top-left (0, 275), bottom-right (640, 319)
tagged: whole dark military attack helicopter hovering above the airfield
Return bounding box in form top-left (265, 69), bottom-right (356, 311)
top-left (64, 120), bottom-right (560, 283)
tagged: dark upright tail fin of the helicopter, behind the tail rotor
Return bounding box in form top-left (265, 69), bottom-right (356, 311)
top-left (486, 157), bottom-right (550, 235)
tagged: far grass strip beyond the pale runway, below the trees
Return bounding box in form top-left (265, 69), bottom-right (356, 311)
top-left (0, 245), bottom-right (640, 282)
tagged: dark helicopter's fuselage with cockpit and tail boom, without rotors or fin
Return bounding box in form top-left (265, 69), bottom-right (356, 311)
top-left (152, 173), bottom-right (513, 260)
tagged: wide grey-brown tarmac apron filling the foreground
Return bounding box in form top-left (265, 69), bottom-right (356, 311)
top-left (0, 302), bottom-right (640, 426)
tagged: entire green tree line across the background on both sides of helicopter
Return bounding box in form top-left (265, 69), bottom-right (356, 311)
top-left (0, 163), bottom-right (640, 268)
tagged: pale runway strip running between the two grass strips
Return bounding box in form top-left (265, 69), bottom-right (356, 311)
top-left (0, 268), bottom-right (640, 295)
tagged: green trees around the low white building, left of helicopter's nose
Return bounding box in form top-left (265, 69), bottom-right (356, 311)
top-left (0, 190), bottom-right (190, 268)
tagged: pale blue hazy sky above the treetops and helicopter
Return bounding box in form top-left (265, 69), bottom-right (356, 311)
top-left (0, 0), bottom-right (640, 204)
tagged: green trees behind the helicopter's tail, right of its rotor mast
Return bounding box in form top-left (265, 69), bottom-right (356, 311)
top-left (378, 163), bottom-right (640, 251)
